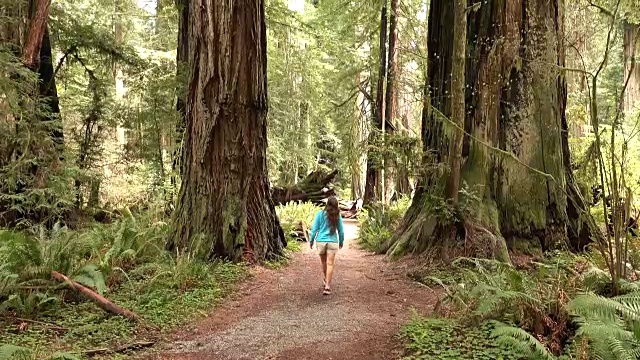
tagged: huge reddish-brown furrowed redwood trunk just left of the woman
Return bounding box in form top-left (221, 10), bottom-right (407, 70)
top-left (169, 0), bottom-right (286, 262)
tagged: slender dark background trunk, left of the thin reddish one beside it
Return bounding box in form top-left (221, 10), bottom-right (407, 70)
top-left (363, 0), bottom-right (387, 204)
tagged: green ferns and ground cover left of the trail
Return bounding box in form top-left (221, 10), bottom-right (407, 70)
top-left (0, 201), bottom-right (315, 360)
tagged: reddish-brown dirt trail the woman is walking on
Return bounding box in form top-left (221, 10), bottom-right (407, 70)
top-left (144, 221), bottom-right (437, 360)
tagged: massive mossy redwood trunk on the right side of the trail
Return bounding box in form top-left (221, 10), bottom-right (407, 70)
top-left (382, 0), bottom-right (584, 261)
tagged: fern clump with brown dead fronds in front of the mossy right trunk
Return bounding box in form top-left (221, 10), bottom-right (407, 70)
top-left (432, 258), bottom-right (578, 359)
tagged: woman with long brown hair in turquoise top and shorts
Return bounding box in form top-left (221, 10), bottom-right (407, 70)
top-left (309, 196), bottom-right (344, 295)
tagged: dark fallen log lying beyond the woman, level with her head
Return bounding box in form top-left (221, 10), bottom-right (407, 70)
top-left (271, 170), bottom-right (338, 205)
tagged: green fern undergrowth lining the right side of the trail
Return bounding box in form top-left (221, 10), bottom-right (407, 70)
top-left (360, 202), bottom-right (640, 360)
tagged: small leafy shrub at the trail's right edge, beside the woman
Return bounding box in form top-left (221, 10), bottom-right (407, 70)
top-left (358, 197), bottom-right (411, 253)
